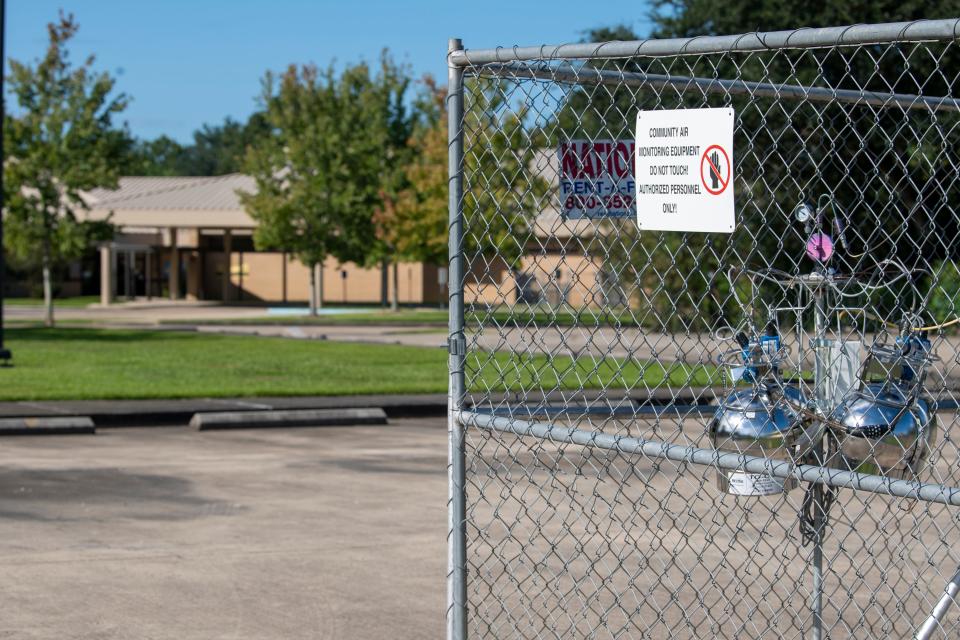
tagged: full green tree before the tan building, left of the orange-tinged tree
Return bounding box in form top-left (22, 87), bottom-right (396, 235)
top-left (241, 64), bottom-right (384, 314)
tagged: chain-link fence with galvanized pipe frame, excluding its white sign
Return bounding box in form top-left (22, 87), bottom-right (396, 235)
top-left (448, 20), bottom-right (960, 639)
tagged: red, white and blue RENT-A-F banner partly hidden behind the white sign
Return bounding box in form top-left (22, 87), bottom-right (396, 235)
top-left (557, 140), bottom-right (636, 220)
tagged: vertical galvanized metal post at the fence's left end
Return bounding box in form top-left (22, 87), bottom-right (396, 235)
top-left (447, 38), bottom-right (467, 640)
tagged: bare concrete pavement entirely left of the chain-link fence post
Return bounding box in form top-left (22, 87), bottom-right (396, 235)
top-left (0, 419), bottom-right (446, 639)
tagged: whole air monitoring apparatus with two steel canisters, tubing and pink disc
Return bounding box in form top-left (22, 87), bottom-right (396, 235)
top-left (710, 196), bottom-right (936, 500)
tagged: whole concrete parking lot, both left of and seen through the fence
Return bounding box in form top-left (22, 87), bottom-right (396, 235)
top-left (0, 418), bottom-right (960, 640)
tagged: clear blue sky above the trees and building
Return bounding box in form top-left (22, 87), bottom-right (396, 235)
top-left (6, 0), bottom-right (648, 141)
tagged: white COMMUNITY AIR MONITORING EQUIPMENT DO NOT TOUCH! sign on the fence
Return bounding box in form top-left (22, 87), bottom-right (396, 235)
top-left (634, 107), bottom-right (736, 233)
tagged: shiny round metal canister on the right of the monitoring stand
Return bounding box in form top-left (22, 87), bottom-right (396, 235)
top-left (830, 383), bottom-right (937, 479)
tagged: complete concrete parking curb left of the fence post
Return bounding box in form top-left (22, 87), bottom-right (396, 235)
top-left (190, 408), bottom-right (387, 431)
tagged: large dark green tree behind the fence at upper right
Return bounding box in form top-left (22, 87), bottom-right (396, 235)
top-left (652, 0), bottom-right (960, 304)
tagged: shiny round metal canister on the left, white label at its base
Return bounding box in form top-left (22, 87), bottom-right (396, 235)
top-left (710, 387), bottom-right (803, 496)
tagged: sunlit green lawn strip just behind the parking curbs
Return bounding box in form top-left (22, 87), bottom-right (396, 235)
top-left (0, 327), bottom-right (715, 400)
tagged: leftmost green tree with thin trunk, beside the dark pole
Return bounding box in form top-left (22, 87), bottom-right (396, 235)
top-left (3, 13), bottom-right (129, 326)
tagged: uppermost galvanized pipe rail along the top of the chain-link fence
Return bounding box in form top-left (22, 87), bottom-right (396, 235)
top-left (449, 18), bottom-right (960, 67)
